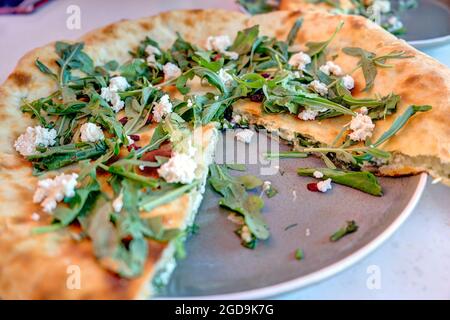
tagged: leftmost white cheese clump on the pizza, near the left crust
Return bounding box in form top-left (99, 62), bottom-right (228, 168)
top-left (14, 126), bottom-right (57, 156)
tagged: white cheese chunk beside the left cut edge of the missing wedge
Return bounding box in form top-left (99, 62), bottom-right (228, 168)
top-left (158, 153), bottom-right (197, 184)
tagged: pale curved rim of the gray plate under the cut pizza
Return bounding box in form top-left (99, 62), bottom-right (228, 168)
top-left (163, 172), bottom-right (428, 300)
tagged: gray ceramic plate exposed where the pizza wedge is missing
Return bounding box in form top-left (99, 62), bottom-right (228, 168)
top-left (161, 134), bottom-right (426, 299)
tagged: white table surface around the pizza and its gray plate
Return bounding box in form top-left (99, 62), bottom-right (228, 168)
top-left (0, 0), bottom-right (450, 299)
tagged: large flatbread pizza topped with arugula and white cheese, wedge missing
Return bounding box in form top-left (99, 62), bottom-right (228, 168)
top-left (0, 10), bottom-right (450, 299)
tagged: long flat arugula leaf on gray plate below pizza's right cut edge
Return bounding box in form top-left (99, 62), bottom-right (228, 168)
top-left (297, 168), bottom-right (383, 196)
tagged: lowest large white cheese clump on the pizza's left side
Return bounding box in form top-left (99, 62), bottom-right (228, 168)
top-left (33, 173), bottom-right (78, 213)
